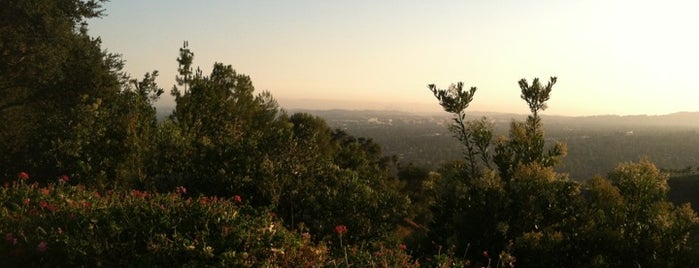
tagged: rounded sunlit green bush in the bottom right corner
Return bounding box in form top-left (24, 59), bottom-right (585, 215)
top-left (548, 159), bottom-right (698, 267)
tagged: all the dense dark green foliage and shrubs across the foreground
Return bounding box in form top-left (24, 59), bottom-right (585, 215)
top-left (0, 0), bottom-right (699, 267)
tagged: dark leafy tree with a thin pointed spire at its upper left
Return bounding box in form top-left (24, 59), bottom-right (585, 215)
top-left (160, 42), bottom-right (288, 197)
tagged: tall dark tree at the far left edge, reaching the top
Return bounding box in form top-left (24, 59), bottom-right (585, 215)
top-left (0, 0), bottom-right (146, 182)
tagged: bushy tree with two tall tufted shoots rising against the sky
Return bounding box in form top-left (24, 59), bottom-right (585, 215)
top-left (429, 77), bottom-right (579, 264)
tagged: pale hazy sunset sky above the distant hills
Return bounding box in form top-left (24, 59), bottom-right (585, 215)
top-left (90, 0), bottom-right (699, 115)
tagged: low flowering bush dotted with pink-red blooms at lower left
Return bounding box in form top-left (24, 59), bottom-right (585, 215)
top-left (0, 176), bottom-right (328, 267)
